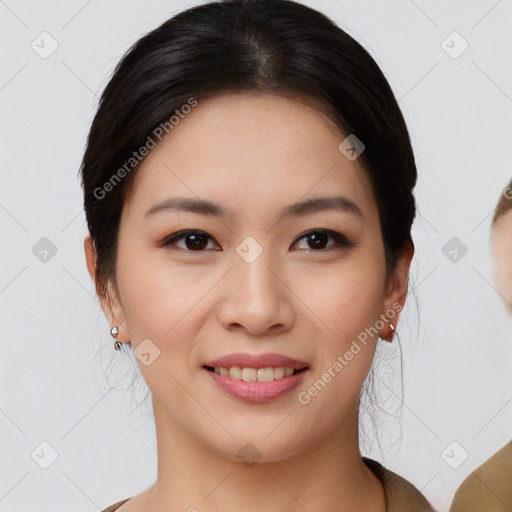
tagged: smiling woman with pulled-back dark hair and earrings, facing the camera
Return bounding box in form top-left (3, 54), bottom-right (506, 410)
top-left (81, 0), bottom-right (432, 512)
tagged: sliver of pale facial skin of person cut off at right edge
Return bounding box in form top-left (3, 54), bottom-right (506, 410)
top-left (491, 210), bottom-right (512, 314)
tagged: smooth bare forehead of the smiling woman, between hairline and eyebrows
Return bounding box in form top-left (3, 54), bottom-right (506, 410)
top-left (124, 94), bottom-right (378, 228)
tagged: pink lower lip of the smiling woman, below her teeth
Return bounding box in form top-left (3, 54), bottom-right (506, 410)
top-left (202, 365), bottom-right (309, 403)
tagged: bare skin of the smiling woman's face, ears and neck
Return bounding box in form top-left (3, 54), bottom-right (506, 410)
top-left (84, 94), bottom-right (413, 512)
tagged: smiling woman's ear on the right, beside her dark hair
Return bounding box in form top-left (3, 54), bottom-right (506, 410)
top-left (380, 241), bottom-right (414, 341)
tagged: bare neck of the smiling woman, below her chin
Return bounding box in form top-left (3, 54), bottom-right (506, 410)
top-left (140, 399), bottom-right (386, 512)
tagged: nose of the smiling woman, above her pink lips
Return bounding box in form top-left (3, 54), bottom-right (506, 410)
top-left (218, 250), bottom-right (295, 335)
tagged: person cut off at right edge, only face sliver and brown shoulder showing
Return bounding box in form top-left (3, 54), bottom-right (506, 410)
top-left (450, 181), bottom-right (512, 512)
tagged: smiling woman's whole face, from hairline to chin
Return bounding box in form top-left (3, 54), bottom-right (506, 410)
top-left (86, 94), bottom-right (412, 461)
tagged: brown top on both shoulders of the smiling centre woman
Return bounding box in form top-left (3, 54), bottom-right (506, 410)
top-left (102, 457), bottom-right (432, 512)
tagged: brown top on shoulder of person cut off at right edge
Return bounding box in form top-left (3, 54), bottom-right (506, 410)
top-left (450, 441), bottom-right (512, 512)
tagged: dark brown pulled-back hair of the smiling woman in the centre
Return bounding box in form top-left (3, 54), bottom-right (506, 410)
top-left (80, 0), bottom-right (416, 304)
